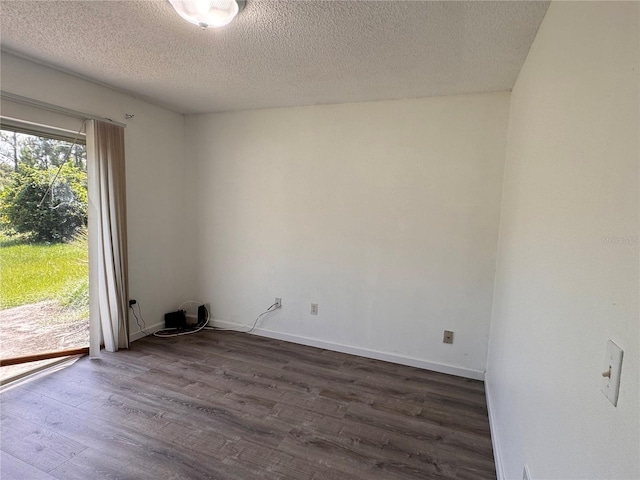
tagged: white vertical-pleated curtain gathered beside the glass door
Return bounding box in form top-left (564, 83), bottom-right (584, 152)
top-left (87, 120), bottom-right (129, 357)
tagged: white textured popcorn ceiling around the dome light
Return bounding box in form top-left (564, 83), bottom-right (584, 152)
top-left (0, 0), bottom-right (548, 113)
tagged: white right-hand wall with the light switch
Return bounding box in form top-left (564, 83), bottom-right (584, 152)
top-left (487, 2), bottom-right (640, 479)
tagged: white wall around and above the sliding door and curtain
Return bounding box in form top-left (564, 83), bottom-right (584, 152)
top-left (1, 52), bottom-right (193, 338)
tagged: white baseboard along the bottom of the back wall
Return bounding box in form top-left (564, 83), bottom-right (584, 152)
top-left (210, 319), bottom-right (484, 380)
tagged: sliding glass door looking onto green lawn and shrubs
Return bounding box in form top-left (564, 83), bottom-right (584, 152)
top-left (0, 126), bottom-right (89, 379)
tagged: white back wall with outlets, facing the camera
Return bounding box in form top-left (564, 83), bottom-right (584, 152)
top-left (186, 93), bottom-right (509, 378)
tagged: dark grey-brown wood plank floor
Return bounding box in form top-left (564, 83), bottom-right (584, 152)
top-left (0, 331), bottom-right (495, 480)
